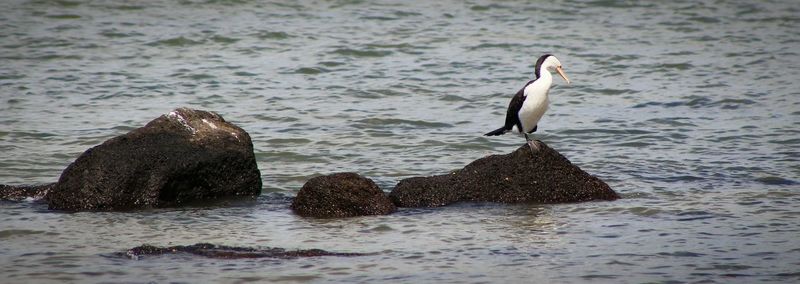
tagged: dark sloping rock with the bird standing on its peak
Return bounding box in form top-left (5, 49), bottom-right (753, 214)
top-left (389, 141), bottom-right (619, 207)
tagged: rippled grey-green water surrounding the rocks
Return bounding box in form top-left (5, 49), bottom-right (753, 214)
top-left (0, 0), bottom-right (800, 283)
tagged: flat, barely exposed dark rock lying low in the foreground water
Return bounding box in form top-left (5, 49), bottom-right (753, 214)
top-left (125, 243), bottom-right (366, 260)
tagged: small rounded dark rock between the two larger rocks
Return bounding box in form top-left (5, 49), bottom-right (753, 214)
top-left (291, 173), bottom-right (397, 218)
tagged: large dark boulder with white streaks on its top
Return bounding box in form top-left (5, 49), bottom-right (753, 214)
top-left (46, 108), bottom-right (261, 211)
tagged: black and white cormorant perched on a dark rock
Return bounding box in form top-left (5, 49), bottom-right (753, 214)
top-left (484, 54), bottom-right (569, 151)
